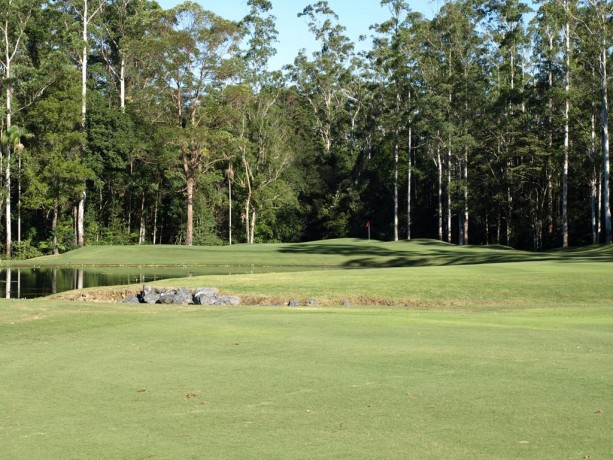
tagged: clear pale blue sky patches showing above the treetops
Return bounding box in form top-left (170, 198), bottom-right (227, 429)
top-left (158, 0), bottom-right (441, 69)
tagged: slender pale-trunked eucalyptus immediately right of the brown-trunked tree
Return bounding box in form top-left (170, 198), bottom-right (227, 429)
top-left (235, 0), bottom-right (295, 243)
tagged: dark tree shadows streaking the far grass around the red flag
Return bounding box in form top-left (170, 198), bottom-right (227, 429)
top-left (279, 239), bottom-right (613, 268)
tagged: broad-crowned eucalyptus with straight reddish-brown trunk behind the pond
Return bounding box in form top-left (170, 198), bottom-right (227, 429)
top-left (150, 2), bottom-right (240, 246)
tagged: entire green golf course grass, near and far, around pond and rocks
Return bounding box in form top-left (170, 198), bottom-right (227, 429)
top-left (0, 239), bottom-right (613, 459)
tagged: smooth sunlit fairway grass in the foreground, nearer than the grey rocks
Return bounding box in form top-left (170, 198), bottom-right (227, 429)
top-left (0, 301), bottom-right (613, 459)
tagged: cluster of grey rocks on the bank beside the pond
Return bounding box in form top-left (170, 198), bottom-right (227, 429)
top-left (124, 285), bottom-right (241, 305)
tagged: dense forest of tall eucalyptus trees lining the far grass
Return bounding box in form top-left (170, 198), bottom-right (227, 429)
top-left (0, 0), bottom-right (613, 258)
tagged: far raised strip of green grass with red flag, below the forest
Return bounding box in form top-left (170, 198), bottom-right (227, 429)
top-left (14, 239), bottom-right (613, 271)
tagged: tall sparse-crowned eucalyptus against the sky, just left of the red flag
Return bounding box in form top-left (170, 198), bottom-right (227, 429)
top-left (289, 1), bottom-right (354, 236)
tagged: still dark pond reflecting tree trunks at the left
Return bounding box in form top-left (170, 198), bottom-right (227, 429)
top-left (0, 267), bottom-right (265, 299)
